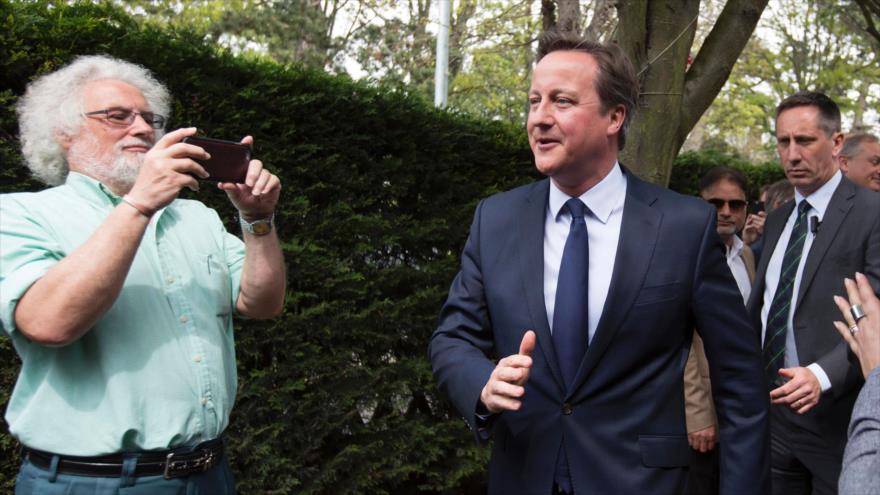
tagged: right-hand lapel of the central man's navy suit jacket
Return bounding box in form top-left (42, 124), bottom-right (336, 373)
top-left (569, 169), bottom-right (663, 396)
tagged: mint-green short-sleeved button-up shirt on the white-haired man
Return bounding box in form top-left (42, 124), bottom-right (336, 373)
top-left (0, 173), bottom-right (244, 456)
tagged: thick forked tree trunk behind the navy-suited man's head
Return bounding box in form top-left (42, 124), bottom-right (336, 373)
top-left (617, 0), bottom-right (767, 186)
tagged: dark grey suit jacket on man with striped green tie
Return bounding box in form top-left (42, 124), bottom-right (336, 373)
top-left (748, 177), bottom-right (880, 452)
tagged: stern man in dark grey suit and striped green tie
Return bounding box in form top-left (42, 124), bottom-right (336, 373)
top-left (748, 92), bottom-right (880, 494)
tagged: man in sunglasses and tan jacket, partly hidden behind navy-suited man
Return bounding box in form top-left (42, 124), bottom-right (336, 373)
top-left (684, 167), bottom-right (755, 494)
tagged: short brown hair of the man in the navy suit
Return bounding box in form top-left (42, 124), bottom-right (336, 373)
top-left (538, 29), bottom-right (639, 149)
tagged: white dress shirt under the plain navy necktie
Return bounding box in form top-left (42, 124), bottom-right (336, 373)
top-left (544, 163), bottom-right (626, 340)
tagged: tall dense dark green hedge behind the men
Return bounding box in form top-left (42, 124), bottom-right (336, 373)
top-left (0, 0), bottom-right (781, 494)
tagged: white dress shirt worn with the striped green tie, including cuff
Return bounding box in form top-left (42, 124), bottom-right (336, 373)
top-left (761, 170), bottom-right (843, 392)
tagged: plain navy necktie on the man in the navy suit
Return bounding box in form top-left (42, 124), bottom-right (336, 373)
top-left (553, 198), bottom-right (590, 493)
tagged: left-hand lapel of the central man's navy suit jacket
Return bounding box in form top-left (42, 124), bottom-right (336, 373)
top-left (519, 179), bottom-right (565, 390)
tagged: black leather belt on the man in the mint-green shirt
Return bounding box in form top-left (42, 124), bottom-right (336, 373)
top-left (22, 438), bottom-right (223, 479)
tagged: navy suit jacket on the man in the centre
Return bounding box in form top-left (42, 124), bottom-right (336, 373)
top-left (429, 172), bottom-right (768, 495)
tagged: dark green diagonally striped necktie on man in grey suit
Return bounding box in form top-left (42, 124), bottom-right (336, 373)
top-left (763, 199), bottom-right (810, 389)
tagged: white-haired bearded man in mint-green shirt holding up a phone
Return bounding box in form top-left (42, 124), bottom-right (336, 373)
top-left (0, 56), bottom-right (285, 494)
